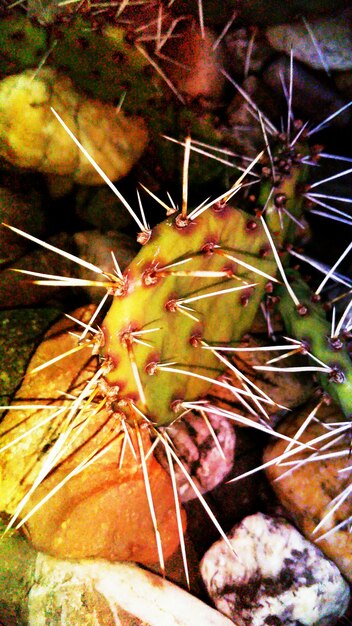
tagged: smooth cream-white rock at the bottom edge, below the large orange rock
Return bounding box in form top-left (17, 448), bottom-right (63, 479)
top-left (28, 553), bottom-right (231, 626)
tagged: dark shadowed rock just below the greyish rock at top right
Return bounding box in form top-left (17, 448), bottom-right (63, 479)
top-left (263, 57), bottom-right (351, 128)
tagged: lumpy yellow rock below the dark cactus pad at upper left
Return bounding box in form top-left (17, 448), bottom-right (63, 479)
top-left (0, 68), bottom-right (148, 185)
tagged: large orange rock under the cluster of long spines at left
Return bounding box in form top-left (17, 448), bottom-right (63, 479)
top-left (0, 307), bottom-right (186, 563)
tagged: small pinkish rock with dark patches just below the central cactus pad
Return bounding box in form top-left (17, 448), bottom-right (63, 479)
top-left (156, 413), bottom-right (236, 502)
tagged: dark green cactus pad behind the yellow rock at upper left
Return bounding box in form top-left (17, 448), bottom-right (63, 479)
top-left (0, 11), bottom-right (230, 184)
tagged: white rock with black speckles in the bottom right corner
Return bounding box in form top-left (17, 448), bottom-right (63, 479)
top-left (201, 513), bottom-right (349, 626)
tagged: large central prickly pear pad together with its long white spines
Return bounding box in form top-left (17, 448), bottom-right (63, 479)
top-left (1, 94), bottom-right (350, 554)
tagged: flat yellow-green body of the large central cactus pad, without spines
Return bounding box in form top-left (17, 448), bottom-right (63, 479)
top-left (102, 205), bottom-right (276, 425)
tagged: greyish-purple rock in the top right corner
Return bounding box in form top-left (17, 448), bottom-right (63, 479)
top-left (266, 9), bottom-right (352, 71)
